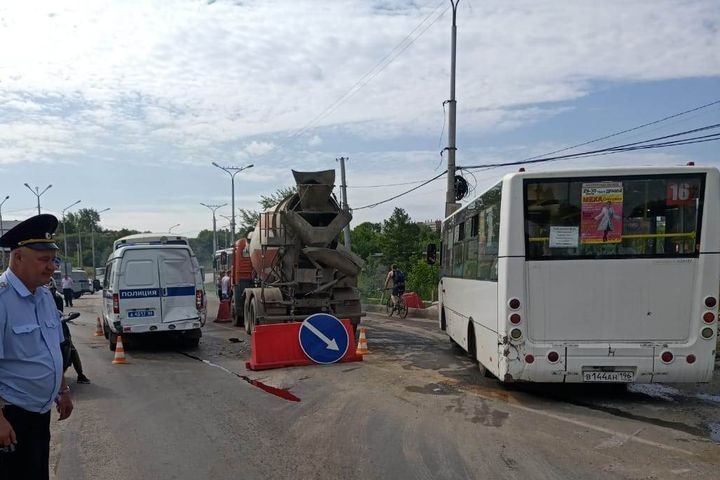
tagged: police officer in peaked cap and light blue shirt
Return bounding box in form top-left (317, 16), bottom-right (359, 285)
top-left (0, 215), bottom-right (73, 480)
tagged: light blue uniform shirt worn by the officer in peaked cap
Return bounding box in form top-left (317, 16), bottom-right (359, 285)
top-left (0, 269), bottom-right (64, 413)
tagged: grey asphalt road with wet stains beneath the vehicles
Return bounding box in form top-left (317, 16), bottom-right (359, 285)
top-left (51, 294), bottom-right (720, 480)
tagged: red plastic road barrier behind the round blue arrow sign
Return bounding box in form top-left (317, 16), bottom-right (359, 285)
top-left (245, 319), bottom-right (362, 370)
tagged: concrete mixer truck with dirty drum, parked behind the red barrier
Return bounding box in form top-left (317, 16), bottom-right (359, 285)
top-left (232, 170), bottom-right (363, 334)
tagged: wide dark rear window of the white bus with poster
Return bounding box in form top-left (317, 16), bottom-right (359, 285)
top-left (524, 173), bottom-right (705, 260)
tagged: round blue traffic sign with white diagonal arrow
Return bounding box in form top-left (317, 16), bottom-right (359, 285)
top-left (298, 313), bottom-right (350, 363)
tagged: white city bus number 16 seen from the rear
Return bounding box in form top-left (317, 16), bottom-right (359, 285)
top-left (438, 164), bottom-right (720, 383)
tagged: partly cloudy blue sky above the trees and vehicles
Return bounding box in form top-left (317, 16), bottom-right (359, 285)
top-left (0, 0), bottom-right (720, 237)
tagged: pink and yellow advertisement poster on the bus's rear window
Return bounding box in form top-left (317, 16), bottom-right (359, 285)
top-left (580, 182), bottom-right (623, 244)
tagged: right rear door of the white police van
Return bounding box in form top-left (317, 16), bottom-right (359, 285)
top-left (158, 248), bottom-right (198, 322)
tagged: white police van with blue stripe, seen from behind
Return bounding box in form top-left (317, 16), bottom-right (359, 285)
top-left (102, 233), bottom-right (207, 350)
